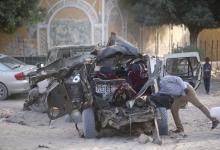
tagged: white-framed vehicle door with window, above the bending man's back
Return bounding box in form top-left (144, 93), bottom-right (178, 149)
top-left (163, 52), bottom-right (202, 89)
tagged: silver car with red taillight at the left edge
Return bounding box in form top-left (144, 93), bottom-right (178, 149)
top-left (0, 54), bottom-right (36, 100)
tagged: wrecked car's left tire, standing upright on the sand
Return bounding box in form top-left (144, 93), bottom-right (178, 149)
top-left (82, 108), bottom-right (96, 139)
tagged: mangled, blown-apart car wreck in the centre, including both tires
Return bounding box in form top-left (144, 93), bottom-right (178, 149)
top-left (24, 36), bottom-right (168, 144)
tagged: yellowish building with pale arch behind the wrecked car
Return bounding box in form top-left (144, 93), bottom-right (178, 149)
top-left (0, 0), bottom-right (192, 57)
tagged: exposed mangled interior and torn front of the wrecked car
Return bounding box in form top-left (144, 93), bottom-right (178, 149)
top-left (92, 56), bottom-right (154, 129)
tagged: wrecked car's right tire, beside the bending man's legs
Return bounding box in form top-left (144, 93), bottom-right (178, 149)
top-left (157, 107), bottom-right (168, 135)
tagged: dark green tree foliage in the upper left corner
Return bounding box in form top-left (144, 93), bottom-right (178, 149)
top-left (0, 0), bottom-right (45, 33)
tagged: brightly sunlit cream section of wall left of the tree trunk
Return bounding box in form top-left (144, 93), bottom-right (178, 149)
top-left (141, 25), bottom-right (190, 57)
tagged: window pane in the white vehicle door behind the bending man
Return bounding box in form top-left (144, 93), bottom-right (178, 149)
top-left (166, 57), bottom-right (199, 76)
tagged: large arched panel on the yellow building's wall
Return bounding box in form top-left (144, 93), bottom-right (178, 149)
top-left (49, 7), bottom-right (92, 47)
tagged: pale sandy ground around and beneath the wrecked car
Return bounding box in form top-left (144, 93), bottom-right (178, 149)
top-left (0, 81), bottom-right (220, 150)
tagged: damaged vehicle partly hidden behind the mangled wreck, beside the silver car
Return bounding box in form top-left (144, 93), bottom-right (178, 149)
top-left (23, 45), bottom-right (95, 113)
